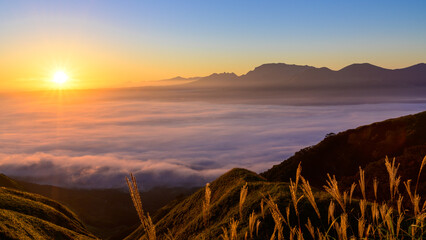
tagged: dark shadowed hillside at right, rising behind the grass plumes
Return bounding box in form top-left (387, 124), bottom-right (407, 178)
top-left (261, 112), bottom-right (426, 199)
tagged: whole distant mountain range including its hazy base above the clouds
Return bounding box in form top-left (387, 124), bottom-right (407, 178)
top-left (99, 63), bottom-right (426, 105)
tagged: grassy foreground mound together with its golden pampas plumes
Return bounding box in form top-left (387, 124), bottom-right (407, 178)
top-left (128, 157), bottom-right (426, 240)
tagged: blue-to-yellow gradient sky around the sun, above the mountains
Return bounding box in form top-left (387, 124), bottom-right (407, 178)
top-left (0, 0), bottom-right (426, 91)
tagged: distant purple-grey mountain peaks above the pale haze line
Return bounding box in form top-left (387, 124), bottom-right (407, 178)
top-left (185, 63), bottom-right (426, 88)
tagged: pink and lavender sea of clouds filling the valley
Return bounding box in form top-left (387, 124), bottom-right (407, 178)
top-left (0, 97), bottom-right (426, 189)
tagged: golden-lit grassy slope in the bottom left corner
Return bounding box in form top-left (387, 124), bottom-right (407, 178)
top-left (0, 188), bottom-right (96, 239)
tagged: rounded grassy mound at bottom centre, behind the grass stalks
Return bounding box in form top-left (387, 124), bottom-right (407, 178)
top-left (126, 169), bottom-right (340, 240)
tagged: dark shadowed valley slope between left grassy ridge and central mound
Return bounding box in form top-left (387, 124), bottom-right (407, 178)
top-left (0, 174), bottom-right (195, 239)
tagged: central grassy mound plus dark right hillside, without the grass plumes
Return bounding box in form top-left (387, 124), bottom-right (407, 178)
top-left (126, 112), bottom-right (426, 240)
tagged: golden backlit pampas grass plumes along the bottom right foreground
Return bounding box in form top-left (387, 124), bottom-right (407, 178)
top-left (126, 157), bottom-right (426, 240)
